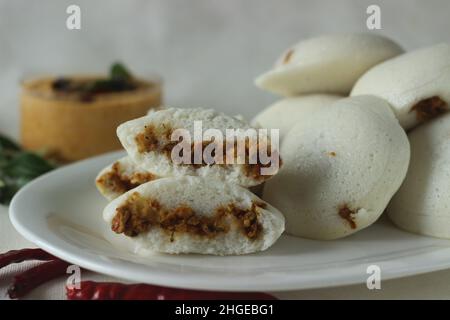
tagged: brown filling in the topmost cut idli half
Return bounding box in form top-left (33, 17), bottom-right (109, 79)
top-left (135, 125), bottom-right (282, 179)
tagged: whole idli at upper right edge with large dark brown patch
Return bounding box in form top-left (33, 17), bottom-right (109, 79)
top-left (351, 43), bottom-right (450, 130)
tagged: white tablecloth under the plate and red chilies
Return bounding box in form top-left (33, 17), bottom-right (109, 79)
top-left (0, 205), bottom-right (450, 299)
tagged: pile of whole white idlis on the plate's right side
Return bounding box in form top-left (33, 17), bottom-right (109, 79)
top-left (252, 34), bottom-right (450, 240)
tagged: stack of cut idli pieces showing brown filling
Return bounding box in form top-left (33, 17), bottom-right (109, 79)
top-left (96, 108), bottom-right (284, 255)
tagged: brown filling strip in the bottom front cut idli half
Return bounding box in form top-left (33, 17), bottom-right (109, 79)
top-left (111, 192), bottom-right (265, 241)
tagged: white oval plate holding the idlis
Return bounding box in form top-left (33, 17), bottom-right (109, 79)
top-left (10, 153), bottom-right (450, 291)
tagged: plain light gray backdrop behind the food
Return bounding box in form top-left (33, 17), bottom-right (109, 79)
top-left (0, 0), bottom-right (450, 135)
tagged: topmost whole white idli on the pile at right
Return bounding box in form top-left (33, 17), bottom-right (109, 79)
top-left (255, 34), bottom-right (403, 96)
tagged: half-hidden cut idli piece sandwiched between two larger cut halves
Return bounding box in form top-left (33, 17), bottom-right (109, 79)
top-left (95, 157), bottom-right (159, 200)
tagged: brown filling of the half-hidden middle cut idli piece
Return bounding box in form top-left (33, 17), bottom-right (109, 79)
top-left (97, 162), bottom-right (156, 194)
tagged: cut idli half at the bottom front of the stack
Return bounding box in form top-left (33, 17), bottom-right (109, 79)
top-left (103, 176), bottom-right (284, 255)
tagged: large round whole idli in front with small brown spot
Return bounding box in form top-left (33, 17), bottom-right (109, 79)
top-left (263, 96), bottom-right (409, 240)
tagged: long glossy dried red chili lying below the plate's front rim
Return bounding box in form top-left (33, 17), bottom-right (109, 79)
top-left (66, 281), bottom-right (276, 300)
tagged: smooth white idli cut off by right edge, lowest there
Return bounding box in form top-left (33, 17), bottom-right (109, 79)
top-left (387, 114), bottom-right (450, 239)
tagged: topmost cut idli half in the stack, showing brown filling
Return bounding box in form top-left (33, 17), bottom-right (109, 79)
top-left (117, 108), bottom-right (280, 187)
